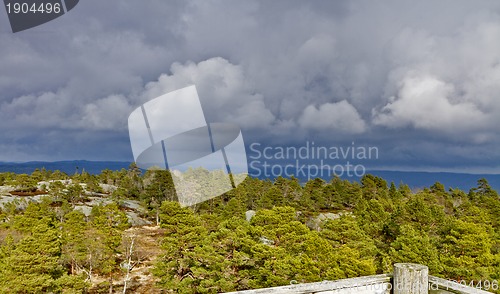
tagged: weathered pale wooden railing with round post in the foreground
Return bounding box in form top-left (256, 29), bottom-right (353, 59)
top-left (227, 263), bottom-right (498, 294)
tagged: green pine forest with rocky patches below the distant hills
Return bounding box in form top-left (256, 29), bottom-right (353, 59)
top-left (0, 164), bottom-right (500, 293)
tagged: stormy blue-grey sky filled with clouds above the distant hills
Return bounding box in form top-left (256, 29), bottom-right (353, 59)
top-left (0, 0), bottom-right (500, 174)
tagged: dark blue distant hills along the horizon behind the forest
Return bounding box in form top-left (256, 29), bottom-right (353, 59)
top-left (0, 160), bottom-right (500, 191)
